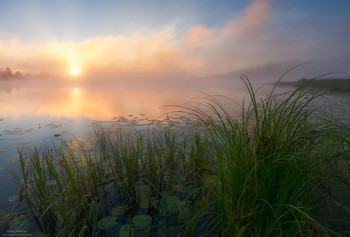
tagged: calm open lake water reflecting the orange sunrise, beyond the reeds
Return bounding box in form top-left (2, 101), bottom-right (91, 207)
top-left (0, 79), bottom-right (350, 214)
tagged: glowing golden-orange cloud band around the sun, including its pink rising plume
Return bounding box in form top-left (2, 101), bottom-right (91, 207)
top-left (0, 0), bottom-right (269, 78)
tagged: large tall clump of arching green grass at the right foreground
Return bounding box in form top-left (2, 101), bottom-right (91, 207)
top-left (178, 78), bottom-right (349, 236)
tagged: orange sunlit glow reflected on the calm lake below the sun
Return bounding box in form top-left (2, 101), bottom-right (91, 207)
top-left (0, 76), bottom-right (249, 120)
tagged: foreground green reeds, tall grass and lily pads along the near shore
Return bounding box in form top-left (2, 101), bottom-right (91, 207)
top-left (1, 78), bottom-right (350, 237)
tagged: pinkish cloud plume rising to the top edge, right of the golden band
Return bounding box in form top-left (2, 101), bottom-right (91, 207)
top-left (180, 0), bottom-right (270, 74)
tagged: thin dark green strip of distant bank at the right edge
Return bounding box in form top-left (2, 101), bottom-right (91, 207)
top-left (279, 78), bottom-right (350, 93)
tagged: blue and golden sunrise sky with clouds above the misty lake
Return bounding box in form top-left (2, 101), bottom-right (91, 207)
top-left (0, 0), bottom-right (350, 79)
